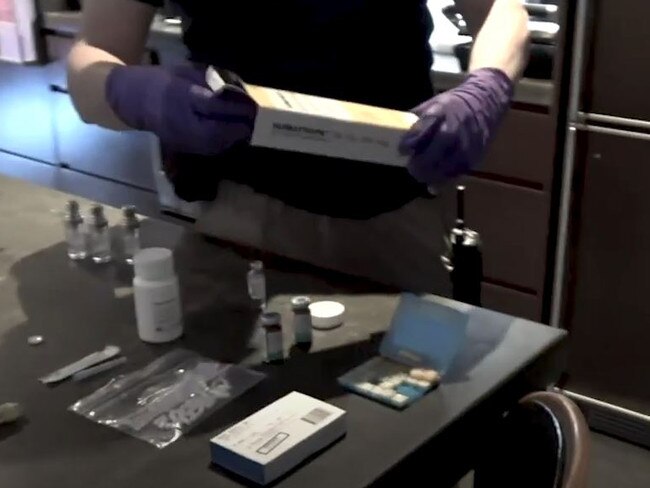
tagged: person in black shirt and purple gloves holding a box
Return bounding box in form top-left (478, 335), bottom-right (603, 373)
top-left (68, 0), bottom-right (528, 289)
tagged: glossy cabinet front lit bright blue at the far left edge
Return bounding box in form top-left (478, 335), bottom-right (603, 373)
top-left (0, 62), bottom-right (56, 163)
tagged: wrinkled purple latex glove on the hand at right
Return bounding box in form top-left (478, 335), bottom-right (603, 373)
top-left (400, 68), bottom-right (514, 185)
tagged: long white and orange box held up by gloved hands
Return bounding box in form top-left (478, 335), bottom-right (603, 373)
top-left (206, 67), bottom-right (418, 166)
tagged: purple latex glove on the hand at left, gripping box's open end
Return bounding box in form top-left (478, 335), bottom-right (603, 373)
top-left (106, 66), bottom-right (256, 156)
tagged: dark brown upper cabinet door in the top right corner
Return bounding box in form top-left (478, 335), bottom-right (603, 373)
top-left (580, 0), bottom-right (650, 120)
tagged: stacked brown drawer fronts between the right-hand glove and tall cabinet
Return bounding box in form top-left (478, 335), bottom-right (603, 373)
top-left (443, 109), bottom-right (557, 320)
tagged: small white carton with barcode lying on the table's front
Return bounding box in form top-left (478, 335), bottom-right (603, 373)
top-left (210, 391), bottom-right (346, 484)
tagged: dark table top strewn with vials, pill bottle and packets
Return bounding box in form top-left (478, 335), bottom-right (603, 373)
top-left (0, 178), bottom-right (564, 488)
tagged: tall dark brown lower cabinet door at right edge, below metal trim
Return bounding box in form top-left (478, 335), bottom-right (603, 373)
top-left (567, 133), bottom-right (650, 412)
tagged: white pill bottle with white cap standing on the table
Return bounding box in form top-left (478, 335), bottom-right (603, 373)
top-left (133, 247), bottom-right (183, 344)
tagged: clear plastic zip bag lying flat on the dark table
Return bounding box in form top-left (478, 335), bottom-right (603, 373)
top-left (70, 350), bottom-right (265, 448)
